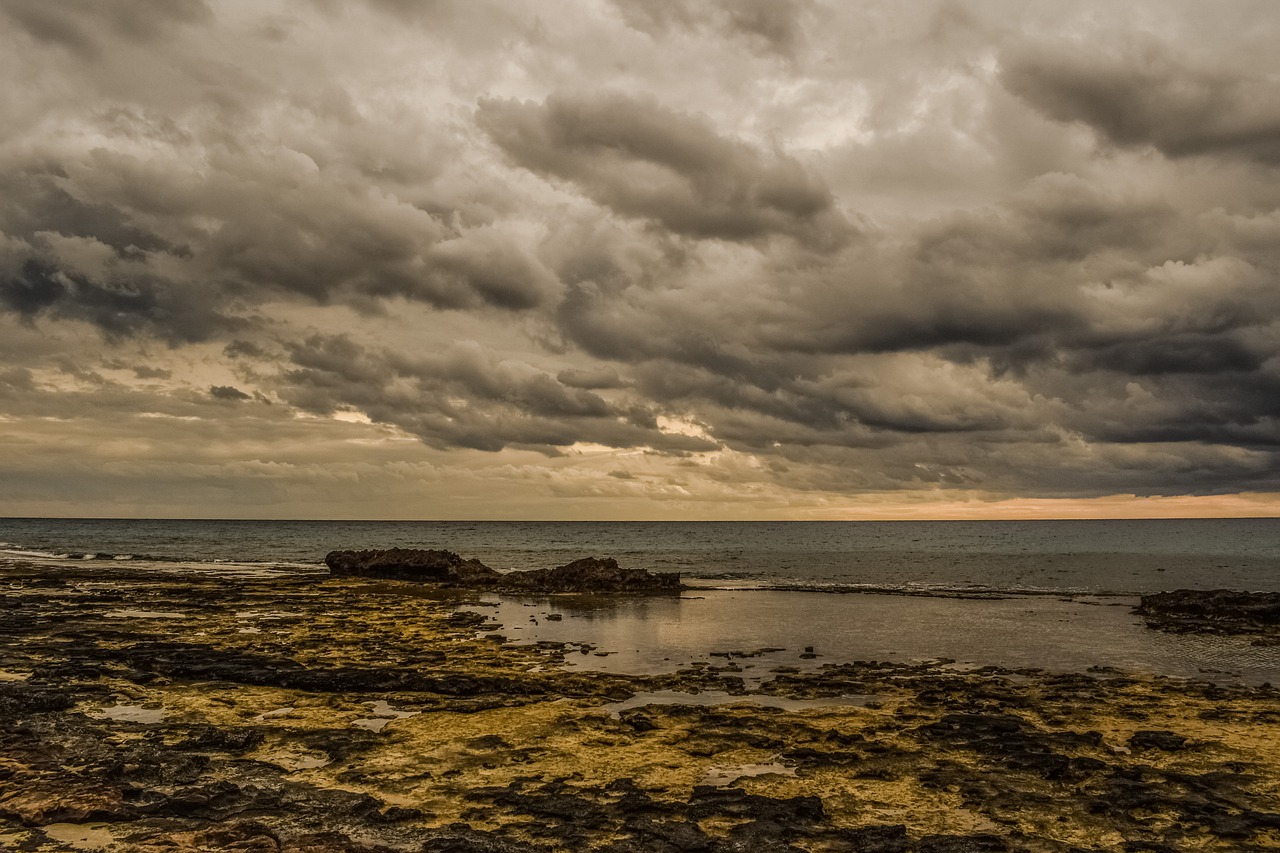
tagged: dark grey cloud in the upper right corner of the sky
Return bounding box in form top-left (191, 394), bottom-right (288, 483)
top-left (1002, 38), bottom-right (1280, 165)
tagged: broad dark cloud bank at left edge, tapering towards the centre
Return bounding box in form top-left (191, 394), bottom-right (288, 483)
top-left (0, 129), bottom-right (559, 342)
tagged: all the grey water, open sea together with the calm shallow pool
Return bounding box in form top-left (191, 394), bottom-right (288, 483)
top-left (0, 519), bottom-right (1280, 683)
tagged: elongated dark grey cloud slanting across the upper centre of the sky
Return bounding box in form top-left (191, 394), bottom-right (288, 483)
top-left (476, 93), bottom-right (850, 247)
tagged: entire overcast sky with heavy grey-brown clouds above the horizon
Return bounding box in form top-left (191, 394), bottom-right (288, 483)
top-left (0, 0), bottom-right (1280, 520)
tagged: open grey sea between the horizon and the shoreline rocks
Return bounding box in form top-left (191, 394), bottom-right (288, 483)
top-left (0, 519), bottom-right (1280, 596)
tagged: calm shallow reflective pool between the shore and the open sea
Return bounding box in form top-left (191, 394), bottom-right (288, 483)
top-left (463, 590), bottom-right (1280, 683)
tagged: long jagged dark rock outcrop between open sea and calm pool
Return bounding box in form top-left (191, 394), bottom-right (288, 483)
top-left (325, 548), bottom-right (684, 593)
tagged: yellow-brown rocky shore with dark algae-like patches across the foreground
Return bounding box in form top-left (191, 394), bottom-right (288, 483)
top-left (0, 565), bottom-right (1280, 853)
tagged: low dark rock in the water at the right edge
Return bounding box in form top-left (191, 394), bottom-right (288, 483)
top-left (1135, 589), bottom-right (1280, 634)
